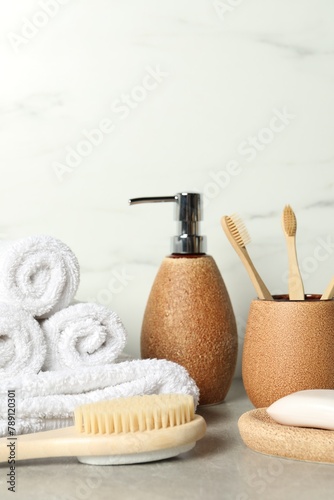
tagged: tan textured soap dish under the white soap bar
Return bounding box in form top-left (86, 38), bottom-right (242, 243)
top-left (238, 408), bottom-right (334, 464)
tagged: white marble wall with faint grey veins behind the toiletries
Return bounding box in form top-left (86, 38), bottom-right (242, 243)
top-left (0, 0), bottom-right (334, 374)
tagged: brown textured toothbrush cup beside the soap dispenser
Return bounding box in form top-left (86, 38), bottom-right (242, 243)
top-left (242, 295), bottom-right (334, 408)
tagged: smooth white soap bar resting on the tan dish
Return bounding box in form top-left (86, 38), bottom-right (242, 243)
top-left (267, 389), bottom-right (334, 430)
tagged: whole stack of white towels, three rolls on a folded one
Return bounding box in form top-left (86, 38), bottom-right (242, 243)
top-left (0, 235), bottom-right (199, 436)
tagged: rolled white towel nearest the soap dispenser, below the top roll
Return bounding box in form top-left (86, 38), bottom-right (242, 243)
top-left (41, 303), bottom-right (127, 370)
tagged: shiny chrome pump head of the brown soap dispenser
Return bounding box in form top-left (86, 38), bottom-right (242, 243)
top-left (129, 193), bottom-right (206, 254)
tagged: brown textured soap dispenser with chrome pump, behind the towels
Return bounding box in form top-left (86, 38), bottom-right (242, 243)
top-left (129, 193), bottom-right (238, 405)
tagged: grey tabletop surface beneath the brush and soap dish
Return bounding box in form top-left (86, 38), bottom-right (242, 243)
top-left (0, 380), bottom-right (334, 500)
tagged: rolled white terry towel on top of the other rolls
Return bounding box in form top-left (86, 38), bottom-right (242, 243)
top-left (0, 235), bottom-right (80, 317)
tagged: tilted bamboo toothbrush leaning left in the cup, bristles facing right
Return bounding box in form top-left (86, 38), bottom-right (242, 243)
top-left (220, 214), bottom-right (273, 300)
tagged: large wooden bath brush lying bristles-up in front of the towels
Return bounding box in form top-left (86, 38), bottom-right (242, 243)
top-left (0, 394), bottom-right (206, 465)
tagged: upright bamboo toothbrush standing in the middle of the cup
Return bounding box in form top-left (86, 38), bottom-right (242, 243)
top-left (282, 205), bottom-right (305, 300)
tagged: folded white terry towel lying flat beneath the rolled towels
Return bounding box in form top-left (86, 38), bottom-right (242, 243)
top-left (0, 359), bottom-right (199, 436)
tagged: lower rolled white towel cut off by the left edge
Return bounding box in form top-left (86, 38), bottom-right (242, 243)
top-left (0, 303), bottom-right (46, 380)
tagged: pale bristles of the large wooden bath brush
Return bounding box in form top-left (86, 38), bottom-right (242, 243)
top-left (74, 394), bottom-right (195, 434)
